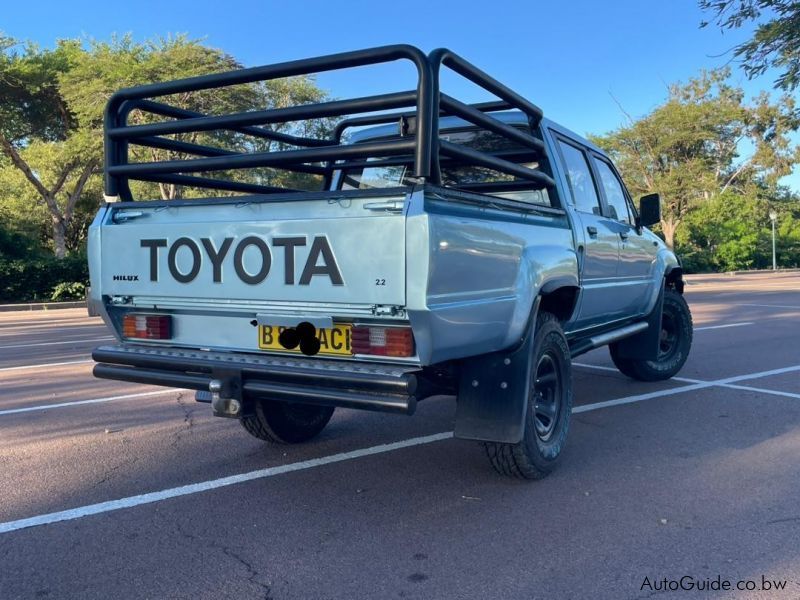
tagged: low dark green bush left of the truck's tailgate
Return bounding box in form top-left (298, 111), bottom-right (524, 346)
top-left (0, 255), bottom-right (89, 303)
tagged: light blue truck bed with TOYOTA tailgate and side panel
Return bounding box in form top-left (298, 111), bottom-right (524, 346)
top-left (89, 185), bottom-right (577, 365)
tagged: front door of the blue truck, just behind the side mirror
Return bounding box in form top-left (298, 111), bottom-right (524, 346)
top-left (592, 153), bottom-right (657, 315)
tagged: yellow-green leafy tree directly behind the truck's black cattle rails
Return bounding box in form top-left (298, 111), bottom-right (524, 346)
top-left (60, 36), bottom-right (326, 200)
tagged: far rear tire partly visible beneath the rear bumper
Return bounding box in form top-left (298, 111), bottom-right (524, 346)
top-left (239, 400), bottom-right (335, 444)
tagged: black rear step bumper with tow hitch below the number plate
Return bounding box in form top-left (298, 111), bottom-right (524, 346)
top-left (92, 344), bottom-right (420, 415)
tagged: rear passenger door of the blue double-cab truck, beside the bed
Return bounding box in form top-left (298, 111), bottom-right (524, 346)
top-left (557, 137), bottom-right (622, 329)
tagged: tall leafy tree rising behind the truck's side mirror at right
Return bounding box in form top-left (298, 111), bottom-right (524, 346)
top-left (593, 69), bottom-right (800, 247)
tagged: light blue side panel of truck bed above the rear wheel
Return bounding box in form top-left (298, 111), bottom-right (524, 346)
top-left (406, 194), bottom-right (577, 364)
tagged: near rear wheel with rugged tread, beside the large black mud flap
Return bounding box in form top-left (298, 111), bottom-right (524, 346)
top-left (484, 312), bottom-right (572, 479)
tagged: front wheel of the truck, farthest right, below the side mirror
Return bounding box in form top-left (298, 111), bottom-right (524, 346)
top-left (609, 288), bottom-right (693, 381)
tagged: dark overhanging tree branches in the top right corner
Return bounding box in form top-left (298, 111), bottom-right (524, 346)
top-left (700, 0), bottom-right (800, 91)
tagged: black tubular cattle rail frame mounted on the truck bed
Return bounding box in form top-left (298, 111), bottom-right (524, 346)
top-left (105, 45), bottom-right (554, 201)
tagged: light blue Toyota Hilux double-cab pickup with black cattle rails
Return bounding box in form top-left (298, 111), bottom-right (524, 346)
top-left (89, 45), bottom-right (692, 479)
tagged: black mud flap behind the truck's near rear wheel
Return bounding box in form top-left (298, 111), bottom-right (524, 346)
top-left (454, 298), bottom-right (539, 444)
